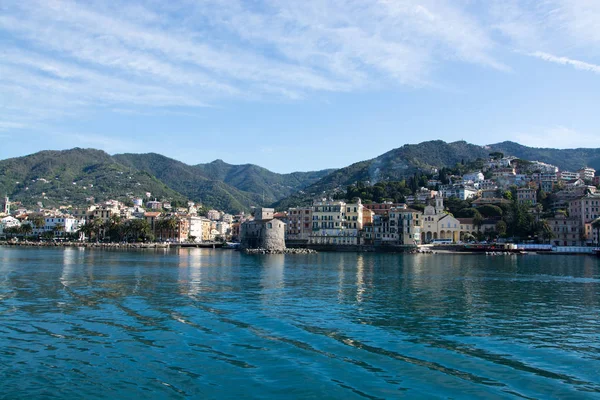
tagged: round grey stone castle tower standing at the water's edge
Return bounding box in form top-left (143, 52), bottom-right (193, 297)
top-left (240, 208), bottom-right (285, 250)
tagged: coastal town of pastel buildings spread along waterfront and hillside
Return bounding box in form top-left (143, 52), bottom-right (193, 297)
top-left (0, 153), bottom-right (600, 250)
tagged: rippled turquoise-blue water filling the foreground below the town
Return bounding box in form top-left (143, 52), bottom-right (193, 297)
top-left (0, 247), bottom-right (600, 399)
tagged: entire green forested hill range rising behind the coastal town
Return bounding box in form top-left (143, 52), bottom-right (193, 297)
top-left (0, 140), bottom-right (600, 212)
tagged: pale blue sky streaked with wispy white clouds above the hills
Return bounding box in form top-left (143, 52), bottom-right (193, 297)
top-left (0, 0), bottom-right (600, 173)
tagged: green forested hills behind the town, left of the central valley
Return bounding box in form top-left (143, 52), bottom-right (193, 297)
top-left (0, 148), bottom-right (330, 212)
